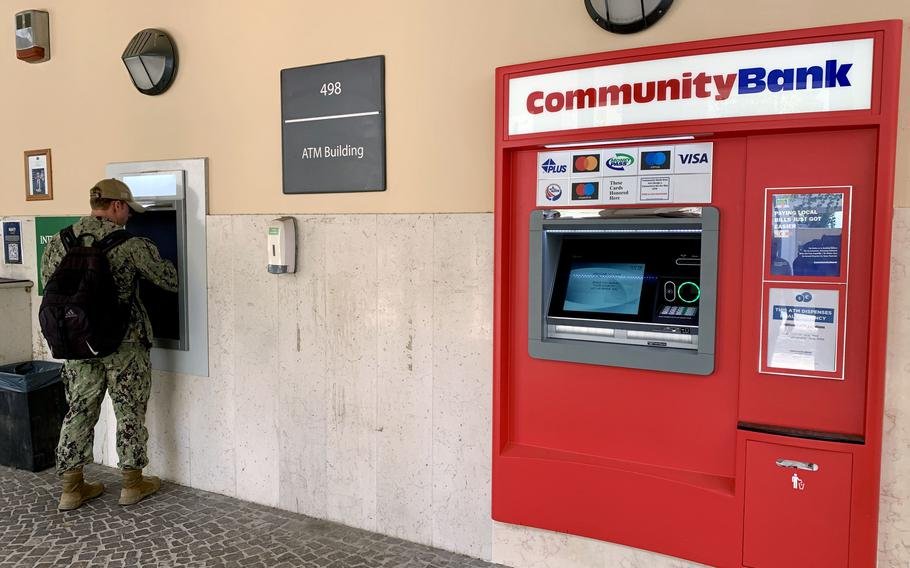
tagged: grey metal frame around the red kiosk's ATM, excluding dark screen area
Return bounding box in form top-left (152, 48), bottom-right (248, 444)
top-left (528, 207), bottom-right (719, 375)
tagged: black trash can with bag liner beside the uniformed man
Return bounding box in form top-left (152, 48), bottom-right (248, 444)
top-left (0, 361), bottom-right (68, 471)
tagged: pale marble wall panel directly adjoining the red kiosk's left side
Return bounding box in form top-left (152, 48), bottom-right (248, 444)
top-left (432, 215), bottom-right (493, 558)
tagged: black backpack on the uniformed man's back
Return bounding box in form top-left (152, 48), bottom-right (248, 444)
top-left (38, 227), bottom-right (132, 359)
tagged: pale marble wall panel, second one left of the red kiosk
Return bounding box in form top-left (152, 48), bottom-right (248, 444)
top-left (376, 215), bottom-right (434, 544)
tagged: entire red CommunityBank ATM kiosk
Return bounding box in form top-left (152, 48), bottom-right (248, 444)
top-left (492, 21), bottom-right (901, 568)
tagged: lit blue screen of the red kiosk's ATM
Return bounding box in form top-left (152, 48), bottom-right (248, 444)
top-left (562, 262), bottom-right (645, 315)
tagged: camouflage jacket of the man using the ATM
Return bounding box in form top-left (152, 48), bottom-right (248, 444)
top-left (41, 216), bottom-right (177, 346)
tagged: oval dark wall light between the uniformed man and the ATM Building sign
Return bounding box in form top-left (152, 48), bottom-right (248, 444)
top-left (121, 28), bottom-right (177, 95)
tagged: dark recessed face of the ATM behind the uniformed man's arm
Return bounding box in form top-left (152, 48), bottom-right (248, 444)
top-left (126, 211), bottom-right (180, 341)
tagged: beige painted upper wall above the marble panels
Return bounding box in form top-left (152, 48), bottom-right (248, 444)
top-left (0, 0), bottom-right (910, 215)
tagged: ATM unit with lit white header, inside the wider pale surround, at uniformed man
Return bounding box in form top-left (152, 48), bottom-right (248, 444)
top-left (122, 171), bottom-right (189, 351)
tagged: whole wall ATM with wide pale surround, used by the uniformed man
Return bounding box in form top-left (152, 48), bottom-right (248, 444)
top-left (107, 158), bottom-right (208, 376)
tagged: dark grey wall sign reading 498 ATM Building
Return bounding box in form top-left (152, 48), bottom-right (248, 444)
top-left (281, 55), bottom-right (386, 194)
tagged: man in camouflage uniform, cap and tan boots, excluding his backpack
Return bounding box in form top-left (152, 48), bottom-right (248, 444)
top-left (41, 179), bottom-right (177, 510)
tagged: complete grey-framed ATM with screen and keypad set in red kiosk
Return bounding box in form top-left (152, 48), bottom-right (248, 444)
top-left (528, 207), bottom-right (718, 374)
